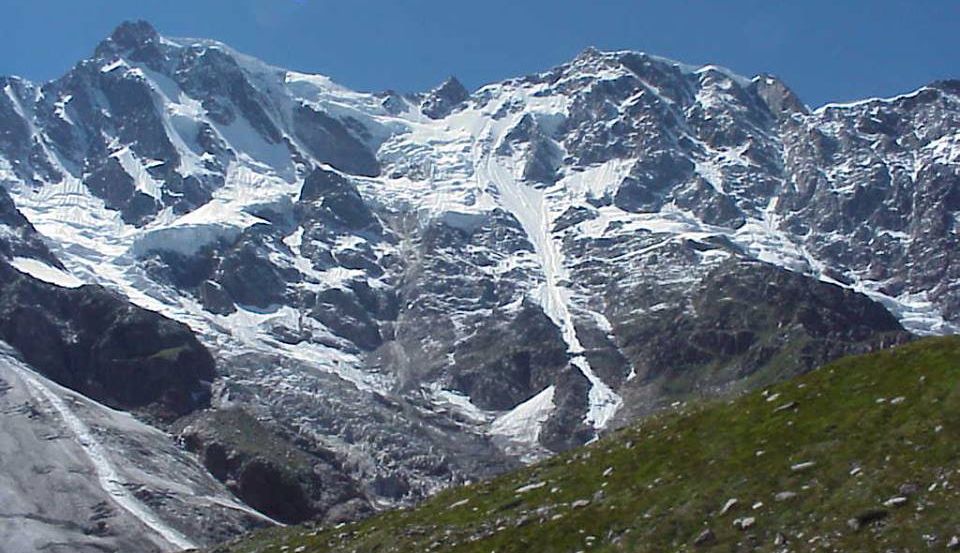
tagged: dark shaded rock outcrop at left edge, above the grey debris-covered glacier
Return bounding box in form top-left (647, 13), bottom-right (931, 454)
top-left (0, 261), bottom-right (216, 419)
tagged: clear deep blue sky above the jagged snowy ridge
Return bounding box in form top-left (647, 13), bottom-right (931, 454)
top-left (0, 0), bottom-right (960, 106)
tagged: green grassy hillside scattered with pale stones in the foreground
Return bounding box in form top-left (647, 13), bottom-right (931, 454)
top-left (216, 337), bottom-right (960, 553)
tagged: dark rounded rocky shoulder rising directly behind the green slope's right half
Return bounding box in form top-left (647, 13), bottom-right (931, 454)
top-left (611, 254), bottom-right (910, 413)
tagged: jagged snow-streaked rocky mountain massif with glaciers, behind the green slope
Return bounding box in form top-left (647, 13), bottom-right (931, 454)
top-left (0, 18), bottom-right (960, 548)
